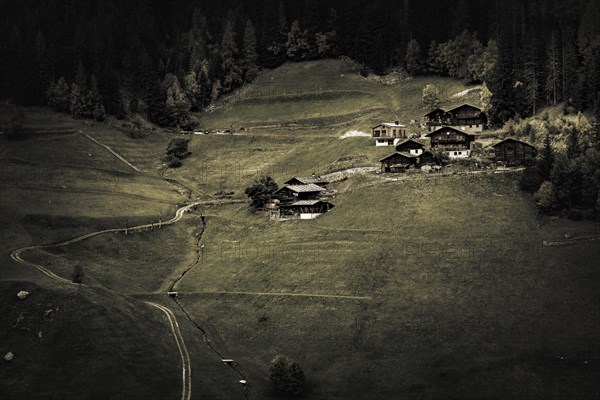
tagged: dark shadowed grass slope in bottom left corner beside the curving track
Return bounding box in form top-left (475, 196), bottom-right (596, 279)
top-left (0, 281), bottom-right (241, 399)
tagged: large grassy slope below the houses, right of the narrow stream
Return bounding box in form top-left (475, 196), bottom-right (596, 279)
top-left (178, 175), bottom-right (600, 399)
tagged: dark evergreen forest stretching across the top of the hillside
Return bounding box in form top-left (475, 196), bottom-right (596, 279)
top-left (0, 0), bottom-right (600, 126)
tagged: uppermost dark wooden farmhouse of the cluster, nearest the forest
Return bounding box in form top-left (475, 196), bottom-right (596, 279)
top-left (423, 104), bottom-right (486, 133)
